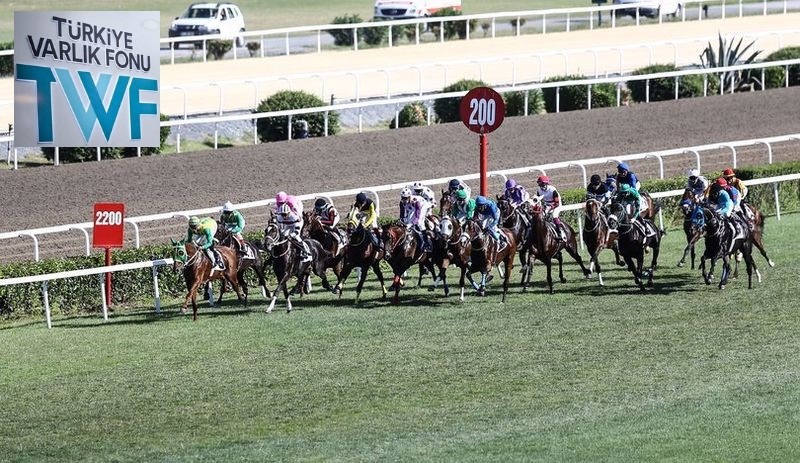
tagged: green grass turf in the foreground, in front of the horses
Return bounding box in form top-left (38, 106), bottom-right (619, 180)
top-left (0, 215), bottom-right (800, 462)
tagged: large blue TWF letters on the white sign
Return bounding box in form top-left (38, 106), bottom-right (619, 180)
top-left (16, 64), bottom-right (158, 143)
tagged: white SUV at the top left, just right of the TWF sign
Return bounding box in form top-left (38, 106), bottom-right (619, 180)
top-left (169, 3), bottom-right (245, 48)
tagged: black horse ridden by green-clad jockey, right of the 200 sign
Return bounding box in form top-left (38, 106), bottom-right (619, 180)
top-left (609, 202), bottom-right (661, 291)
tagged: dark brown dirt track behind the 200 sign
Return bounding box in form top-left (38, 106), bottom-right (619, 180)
top-left (0, 88), bottom-right (800, 261)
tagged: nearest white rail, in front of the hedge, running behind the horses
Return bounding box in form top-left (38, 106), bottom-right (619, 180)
top-left (0, 174), bottom-right (800, 328)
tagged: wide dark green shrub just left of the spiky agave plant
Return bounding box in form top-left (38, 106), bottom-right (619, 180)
top-left (628, 64), bottom-right (719, 102)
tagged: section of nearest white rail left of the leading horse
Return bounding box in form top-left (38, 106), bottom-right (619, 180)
top-left (0, 259), bottom-right (173, 328)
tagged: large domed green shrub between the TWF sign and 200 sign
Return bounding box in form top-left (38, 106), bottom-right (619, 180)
top-left (256, 90), bottom-right (340, 142)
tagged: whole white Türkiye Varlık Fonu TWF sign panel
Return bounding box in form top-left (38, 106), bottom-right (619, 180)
top-left (14, 11), bottom-right (160, 147)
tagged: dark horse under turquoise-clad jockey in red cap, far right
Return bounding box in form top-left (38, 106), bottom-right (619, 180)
top-left (693, 206), bottom-right (761, 289)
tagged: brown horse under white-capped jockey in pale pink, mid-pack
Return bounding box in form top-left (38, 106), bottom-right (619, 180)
top-left (381, 224), bottom-right (435, 304)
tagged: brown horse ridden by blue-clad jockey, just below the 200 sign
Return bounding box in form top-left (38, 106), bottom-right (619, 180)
top-left (459, 218), bottom-right (517, 302)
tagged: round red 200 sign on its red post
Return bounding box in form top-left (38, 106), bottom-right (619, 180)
top-left (459, 87), bottom-right (506, 196)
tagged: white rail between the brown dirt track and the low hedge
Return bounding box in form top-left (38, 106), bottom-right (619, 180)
top-left (0, 133), bottom-right (800, 261)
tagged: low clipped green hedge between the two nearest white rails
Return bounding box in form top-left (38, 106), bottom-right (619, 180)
top-left (0, 161), bottom-right (800, 318)
